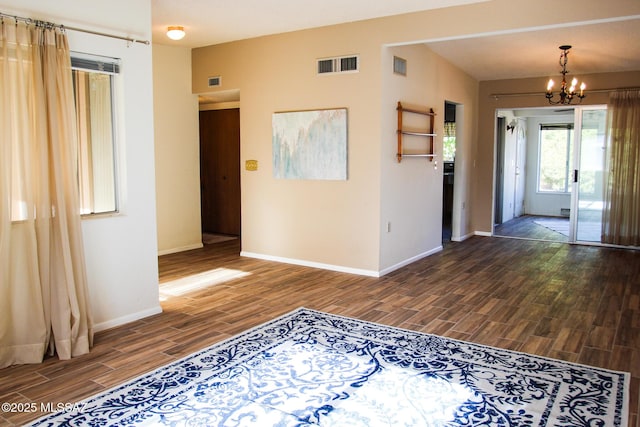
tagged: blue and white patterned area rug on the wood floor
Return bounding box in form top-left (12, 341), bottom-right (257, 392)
top-left (35, 308), bottom-right (629, 427)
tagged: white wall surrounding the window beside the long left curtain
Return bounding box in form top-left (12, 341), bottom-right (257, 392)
top-left (0, 0), bottom-right (161, 330)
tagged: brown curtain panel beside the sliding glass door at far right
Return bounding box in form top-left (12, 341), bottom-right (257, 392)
top-left (602, 90), bottom-right (640, 246)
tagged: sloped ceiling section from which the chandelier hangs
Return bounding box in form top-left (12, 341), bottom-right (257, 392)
top-left (428, 17), bottom-right (640, 81)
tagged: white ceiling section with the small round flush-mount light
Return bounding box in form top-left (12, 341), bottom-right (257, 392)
top-left (151, 0), bottom-right (488, 47)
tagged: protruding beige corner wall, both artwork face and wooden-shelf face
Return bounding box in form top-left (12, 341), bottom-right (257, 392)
top-left (193, 27), bottom-right (477, 275)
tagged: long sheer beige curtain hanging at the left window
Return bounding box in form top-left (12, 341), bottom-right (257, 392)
top-left (0, 18), bottom-right (93, 367)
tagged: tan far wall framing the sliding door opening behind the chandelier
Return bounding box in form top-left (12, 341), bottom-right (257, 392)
top-left (472, 71), bottom-right (640, 233)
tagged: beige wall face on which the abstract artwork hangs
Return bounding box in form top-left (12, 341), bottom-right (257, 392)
top-left (193, 23), bottom-right (380, 274)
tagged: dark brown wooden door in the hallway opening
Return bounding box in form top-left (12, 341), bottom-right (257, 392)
top-left (200, 108), bottom-right (240, 236)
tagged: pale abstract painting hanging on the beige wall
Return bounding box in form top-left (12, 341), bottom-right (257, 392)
top-left (272, 108), bottom-right (347, 180)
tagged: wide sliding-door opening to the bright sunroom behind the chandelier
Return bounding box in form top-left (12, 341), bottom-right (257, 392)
top-left (493, 106), bottom-right (606, 243)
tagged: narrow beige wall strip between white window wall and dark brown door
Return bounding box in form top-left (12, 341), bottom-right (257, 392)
top-left (153, 44), bottom-right (202, 254)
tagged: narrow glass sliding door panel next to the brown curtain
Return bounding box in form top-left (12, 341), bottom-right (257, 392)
top-left (576, 108), bottom-right (607, 242)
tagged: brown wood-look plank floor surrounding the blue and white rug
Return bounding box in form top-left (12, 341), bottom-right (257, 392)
top-left (0, 237), bottom-right (640, 426)
